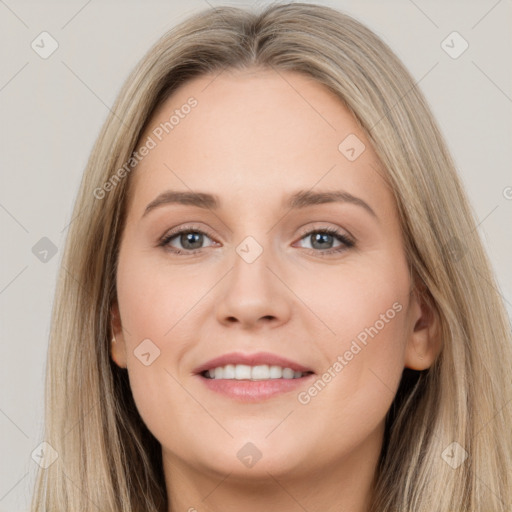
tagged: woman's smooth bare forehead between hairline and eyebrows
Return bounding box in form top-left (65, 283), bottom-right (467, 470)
top-left (126, 69), bottom-right (392, 218)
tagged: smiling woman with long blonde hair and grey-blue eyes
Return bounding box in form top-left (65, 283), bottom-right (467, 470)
top-left (33, 3), bottom-right (512, 512)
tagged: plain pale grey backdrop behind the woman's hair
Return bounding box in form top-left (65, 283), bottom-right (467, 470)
top-left (0, 0), bottom-right (512, 512)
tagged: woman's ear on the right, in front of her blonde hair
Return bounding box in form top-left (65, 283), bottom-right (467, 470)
top-left (405, 282), bottom-right (442, 370)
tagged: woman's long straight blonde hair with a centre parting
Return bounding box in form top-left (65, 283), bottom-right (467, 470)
top-left (32, 3), bottom-right (512, 512)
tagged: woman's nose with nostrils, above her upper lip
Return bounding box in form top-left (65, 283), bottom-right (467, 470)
top-left (216, 245), bottom-right (293, 329)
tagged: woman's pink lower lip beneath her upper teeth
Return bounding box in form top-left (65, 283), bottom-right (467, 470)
top-left (198, 373), bottom-right (315, 402)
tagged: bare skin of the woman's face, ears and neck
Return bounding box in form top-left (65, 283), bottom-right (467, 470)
top-left (111, 69), bottom-right (440, 512)
